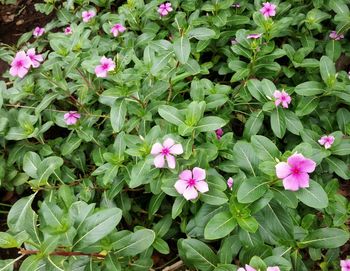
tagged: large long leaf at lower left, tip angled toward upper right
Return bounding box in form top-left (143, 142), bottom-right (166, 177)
top-left (73, 208), bottom-right (122, 249)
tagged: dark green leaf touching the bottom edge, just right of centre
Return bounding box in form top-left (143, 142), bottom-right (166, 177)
top-left (181, 239), bottom-right (218, 271)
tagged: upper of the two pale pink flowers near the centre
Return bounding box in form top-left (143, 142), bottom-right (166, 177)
top-left (151, 138), bottom-right (183, 168)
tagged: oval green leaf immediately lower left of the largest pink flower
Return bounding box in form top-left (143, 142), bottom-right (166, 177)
top-left (237, 177), bottom-right (269, 203)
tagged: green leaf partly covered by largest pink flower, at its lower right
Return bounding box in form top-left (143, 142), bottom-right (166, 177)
top-left (295, 182), bottom-right (328, 209)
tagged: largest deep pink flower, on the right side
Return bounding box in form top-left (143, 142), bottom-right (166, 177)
top-left (276, 153), bottom-right (316, 191)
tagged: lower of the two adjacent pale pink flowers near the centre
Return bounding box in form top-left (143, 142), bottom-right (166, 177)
top-left (174, 167), bottom-right (209, 200)
